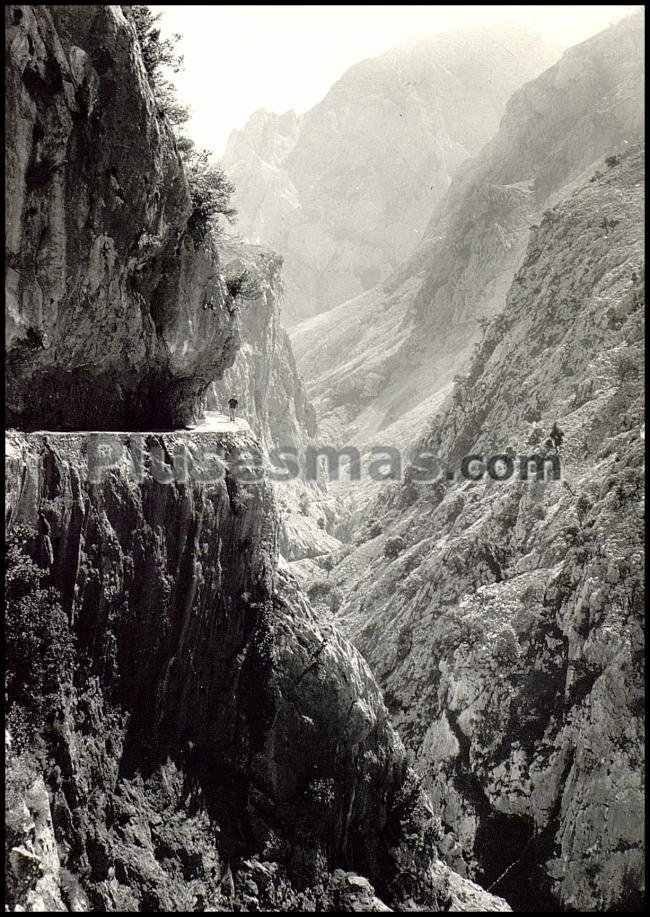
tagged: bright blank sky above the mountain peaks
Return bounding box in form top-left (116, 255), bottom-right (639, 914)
top-left (152, 5), bottom-right (640, 155)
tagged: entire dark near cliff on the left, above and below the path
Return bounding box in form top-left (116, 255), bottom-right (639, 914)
top-left (5, 6), bottom-right (507, 911)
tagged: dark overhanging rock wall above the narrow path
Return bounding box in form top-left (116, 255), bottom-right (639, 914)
top-left (6, 6), bottom-right (238, 429)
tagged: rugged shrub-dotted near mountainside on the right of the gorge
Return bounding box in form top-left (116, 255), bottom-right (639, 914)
top-left (330, 149), bottom-right (644, 910)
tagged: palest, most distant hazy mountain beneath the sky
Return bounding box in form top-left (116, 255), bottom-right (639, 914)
top-left (224, 28), bottom-right (553, 326)
